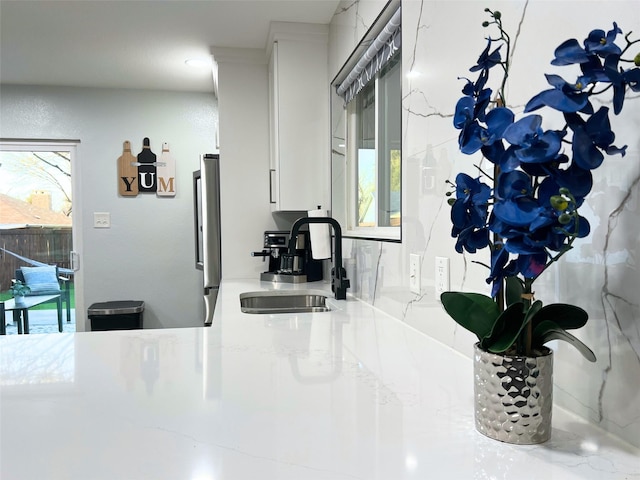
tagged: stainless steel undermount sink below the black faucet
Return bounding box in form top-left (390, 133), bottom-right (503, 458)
top-left (240, 291), bottom-right (330, 314)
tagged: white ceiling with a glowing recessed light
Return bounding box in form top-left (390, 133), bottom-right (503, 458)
top-left (0, 0), bottom-right (339, 92)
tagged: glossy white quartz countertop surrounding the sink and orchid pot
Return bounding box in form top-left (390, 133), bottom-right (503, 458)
top-left (0, 280), bottom-right (640, 480)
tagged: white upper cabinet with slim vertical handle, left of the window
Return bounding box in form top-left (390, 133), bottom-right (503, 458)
top-left (268, 22), bottom-right (330, 211)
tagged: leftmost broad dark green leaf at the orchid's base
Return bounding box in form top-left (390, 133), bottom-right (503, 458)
top-left (440, 292), bottom-right (500, 340)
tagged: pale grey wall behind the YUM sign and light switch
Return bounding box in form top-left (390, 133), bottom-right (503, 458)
top-left (0, 85), bottom-right (218, 330)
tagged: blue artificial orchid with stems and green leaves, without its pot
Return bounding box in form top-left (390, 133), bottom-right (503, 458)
top-left (441, 8), bottom-right (640, 361)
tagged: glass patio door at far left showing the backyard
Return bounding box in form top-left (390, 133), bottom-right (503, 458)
top-left (0, 140), bottom-right (83, 334)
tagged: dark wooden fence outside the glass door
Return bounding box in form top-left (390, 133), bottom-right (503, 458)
top-left (0, 227), bottom-right (73, 292)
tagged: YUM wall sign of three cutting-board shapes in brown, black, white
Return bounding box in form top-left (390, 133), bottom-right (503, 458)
top-left (118, 137), bottom-right (176, 197)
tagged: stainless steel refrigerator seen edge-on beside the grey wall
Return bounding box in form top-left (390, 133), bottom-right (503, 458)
top-left (193, 153), bottom-right (222, 326)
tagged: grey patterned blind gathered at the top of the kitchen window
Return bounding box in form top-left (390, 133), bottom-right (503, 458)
top-left (336, 7), bottom-right (402, 105)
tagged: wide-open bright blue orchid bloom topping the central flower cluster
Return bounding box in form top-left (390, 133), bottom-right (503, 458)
top-left (504, 115), bottom-right (564, 163)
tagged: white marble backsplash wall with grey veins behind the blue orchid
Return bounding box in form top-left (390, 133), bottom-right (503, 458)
top-left (329, 0), bottom-right (640, 446)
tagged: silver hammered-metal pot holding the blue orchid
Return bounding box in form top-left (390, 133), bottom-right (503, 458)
top-left (474, 343), bottom-right (553, 445)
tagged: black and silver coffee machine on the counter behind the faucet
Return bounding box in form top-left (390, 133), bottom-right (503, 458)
top-left (251, 231), bottom-right (322, 283)
